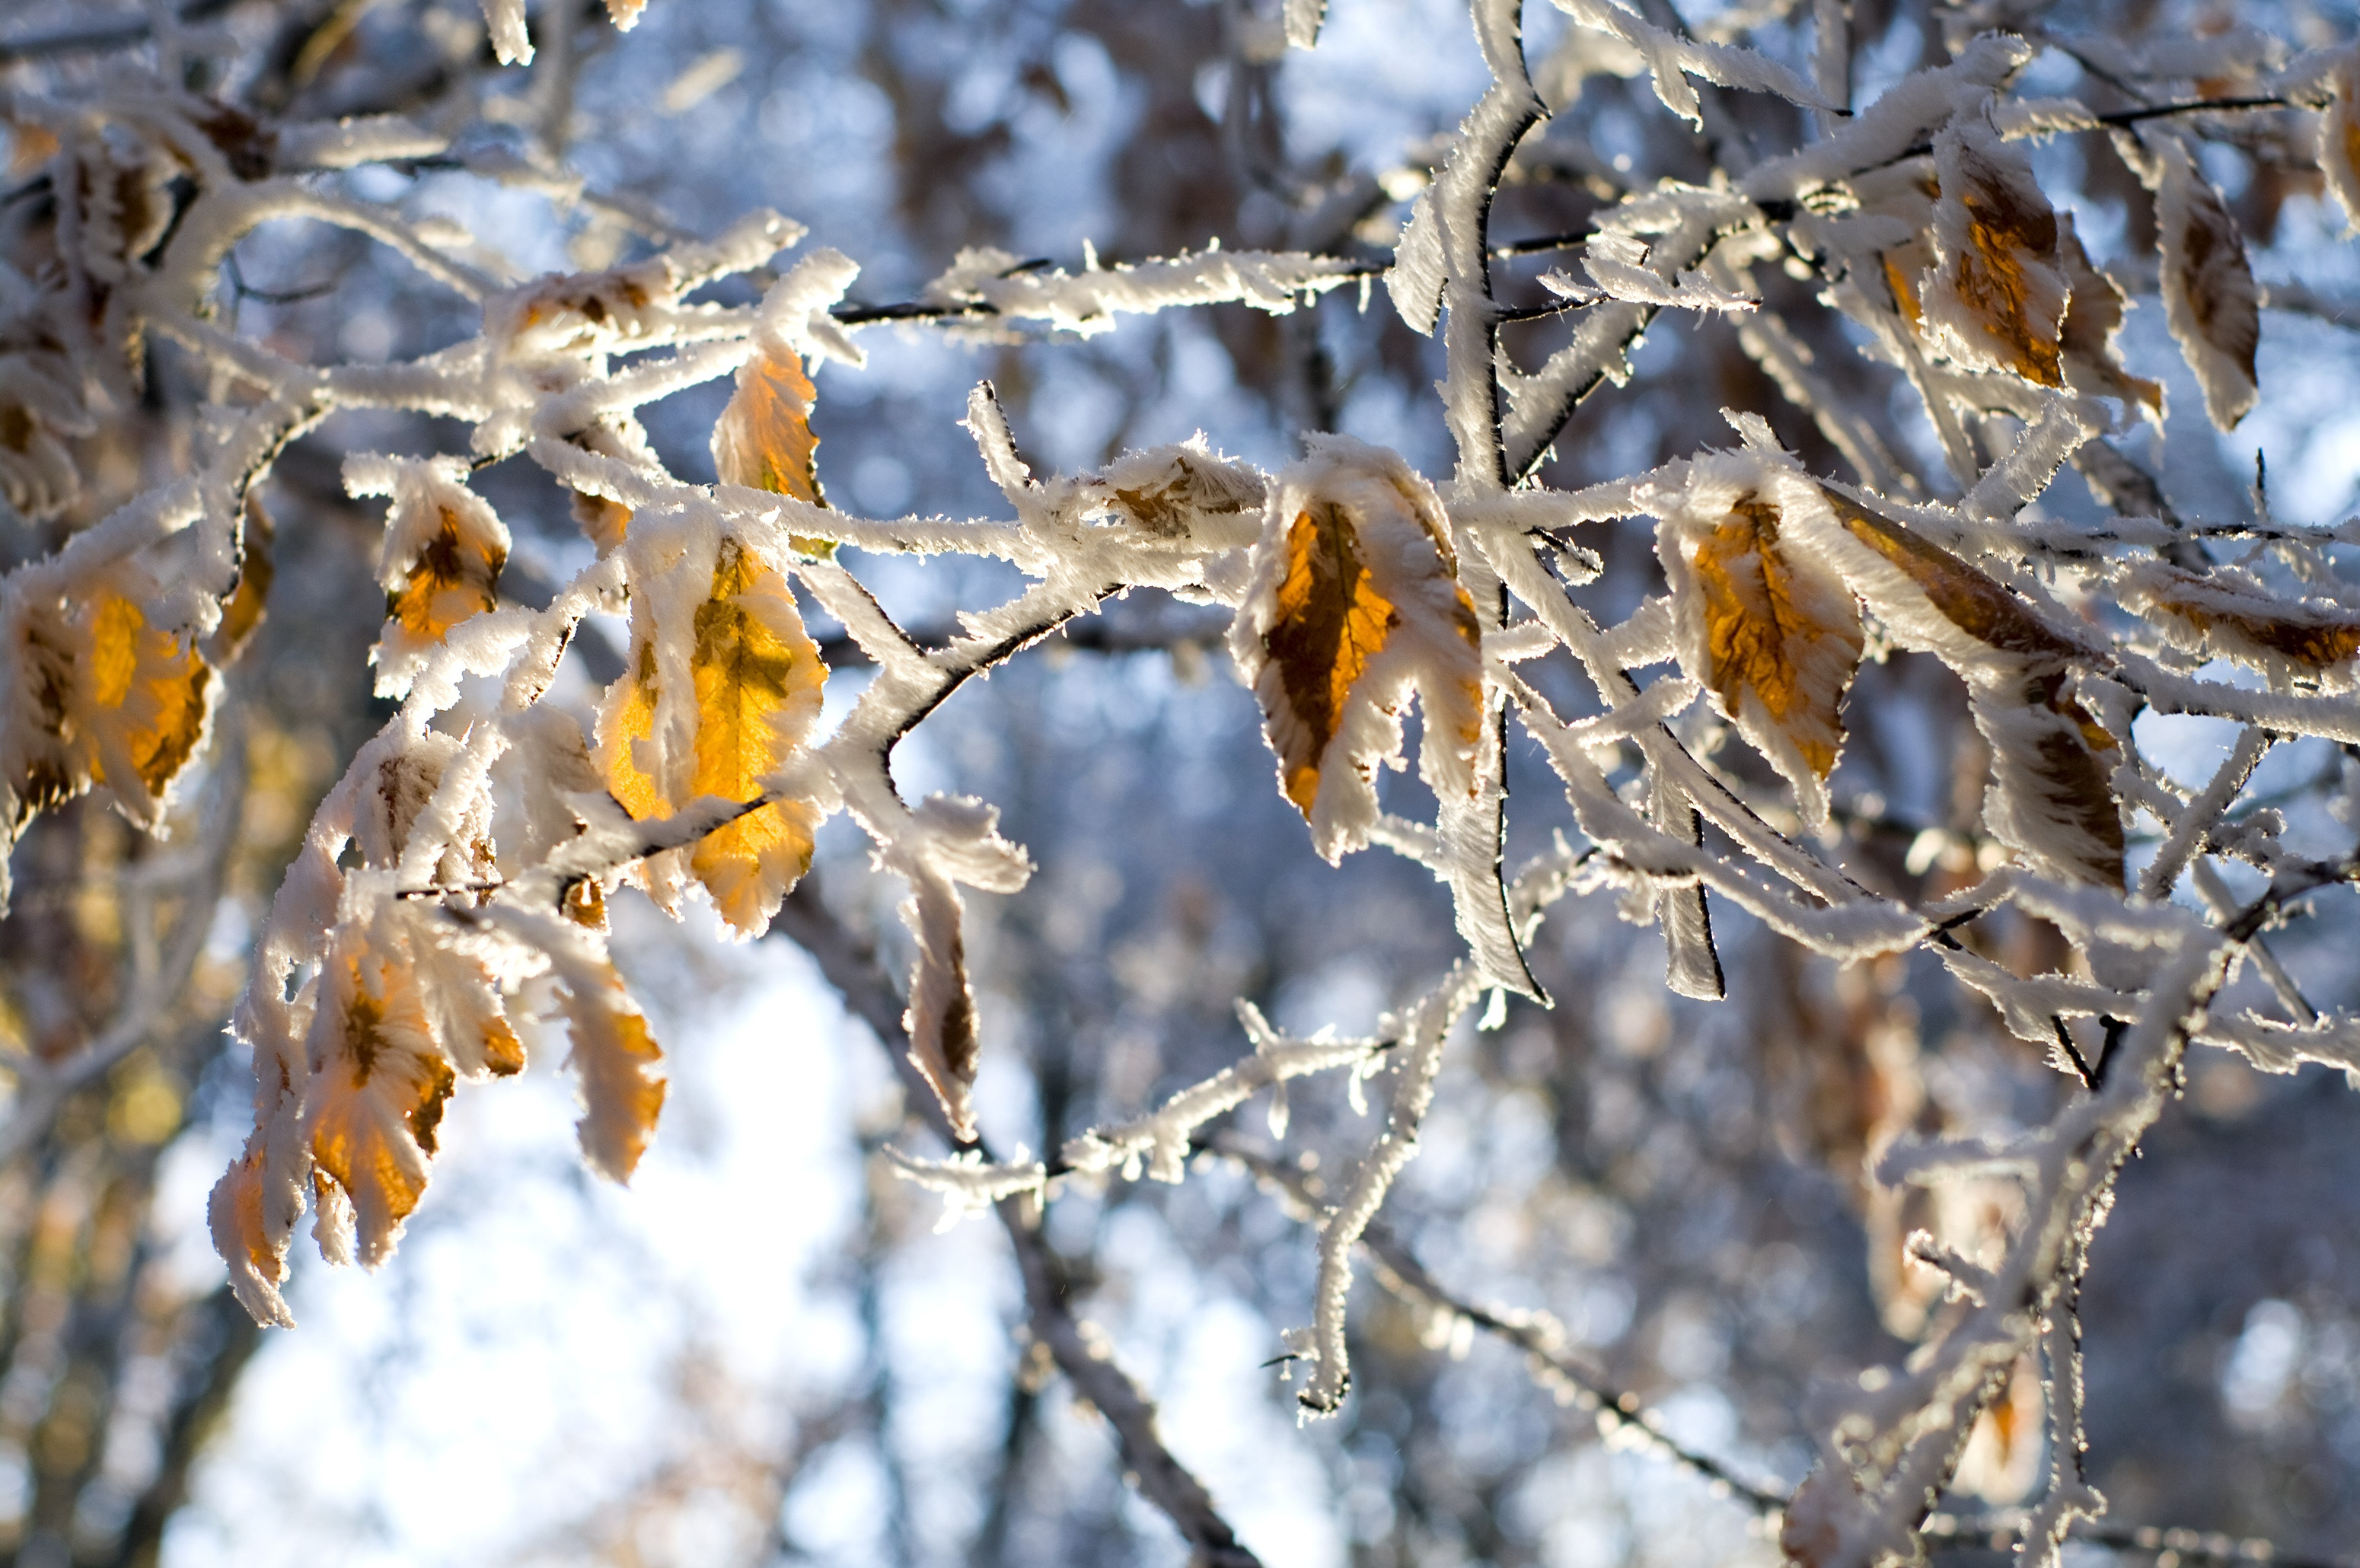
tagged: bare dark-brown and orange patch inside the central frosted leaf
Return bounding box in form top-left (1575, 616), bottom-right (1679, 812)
top-left (1263, 502), bottom-right (1402, 818)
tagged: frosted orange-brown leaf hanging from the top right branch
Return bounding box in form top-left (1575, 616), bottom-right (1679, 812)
top-left (1921, 118), bottom-right (2070, 387)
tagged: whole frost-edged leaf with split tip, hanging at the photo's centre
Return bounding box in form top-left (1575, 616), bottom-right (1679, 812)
top-left (1229, 436), bottom-right (1482, 861)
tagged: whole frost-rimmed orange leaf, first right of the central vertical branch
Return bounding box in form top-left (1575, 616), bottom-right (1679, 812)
top-left (1657, 464), bottom-right (1864, 825)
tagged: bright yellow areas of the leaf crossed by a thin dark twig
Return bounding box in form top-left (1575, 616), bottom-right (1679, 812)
top-left (599, 540), bottom-right (826, 936)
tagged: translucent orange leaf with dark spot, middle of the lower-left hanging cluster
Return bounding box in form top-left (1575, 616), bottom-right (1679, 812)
top-left (305, 950), bottom-right (458, 1266)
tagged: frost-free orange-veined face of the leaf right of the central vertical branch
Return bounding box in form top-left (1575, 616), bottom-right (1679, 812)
top-left (1690, 496), bottom-right (1864, 816)
